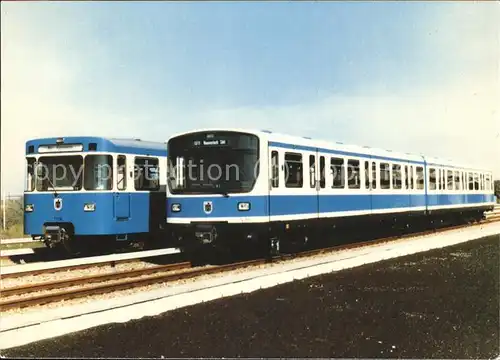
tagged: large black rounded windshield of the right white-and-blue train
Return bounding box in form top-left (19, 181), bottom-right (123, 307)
top-left (168, 131), bottom-right (259, 194)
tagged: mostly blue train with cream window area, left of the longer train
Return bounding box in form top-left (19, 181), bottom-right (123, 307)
top-left (24, 137), bottom-right (167, 253)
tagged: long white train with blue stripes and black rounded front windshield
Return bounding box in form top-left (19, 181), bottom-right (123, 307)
top-left (167, 129), bottom-right (495, 255)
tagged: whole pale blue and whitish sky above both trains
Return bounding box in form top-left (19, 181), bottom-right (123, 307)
top-left (1, 2), bottom-right (500, 192)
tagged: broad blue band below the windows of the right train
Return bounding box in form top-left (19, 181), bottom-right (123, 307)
top-left (167, 194), bottom-right (493, 219)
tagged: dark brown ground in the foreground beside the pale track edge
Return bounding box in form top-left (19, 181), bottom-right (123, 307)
top-left (2, 235), bottom-right (500, 358)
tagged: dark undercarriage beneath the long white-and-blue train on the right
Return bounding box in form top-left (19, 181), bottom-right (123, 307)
top-left (169, 208), bottom-right (488, 258)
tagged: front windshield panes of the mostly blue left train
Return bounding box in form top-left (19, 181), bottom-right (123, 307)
top-left (26, 155), bottom-right (113, 192)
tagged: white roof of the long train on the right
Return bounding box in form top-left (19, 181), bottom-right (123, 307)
top-left (166, 128), bottom-right (490, 172)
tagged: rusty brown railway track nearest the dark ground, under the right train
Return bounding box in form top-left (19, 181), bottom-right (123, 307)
top-left (0, 217), bottom-right (500, 311)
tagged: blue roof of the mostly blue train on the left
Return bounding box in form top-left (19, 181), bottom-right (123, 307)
top-left (26, 136), bottom-right (167, 156)
